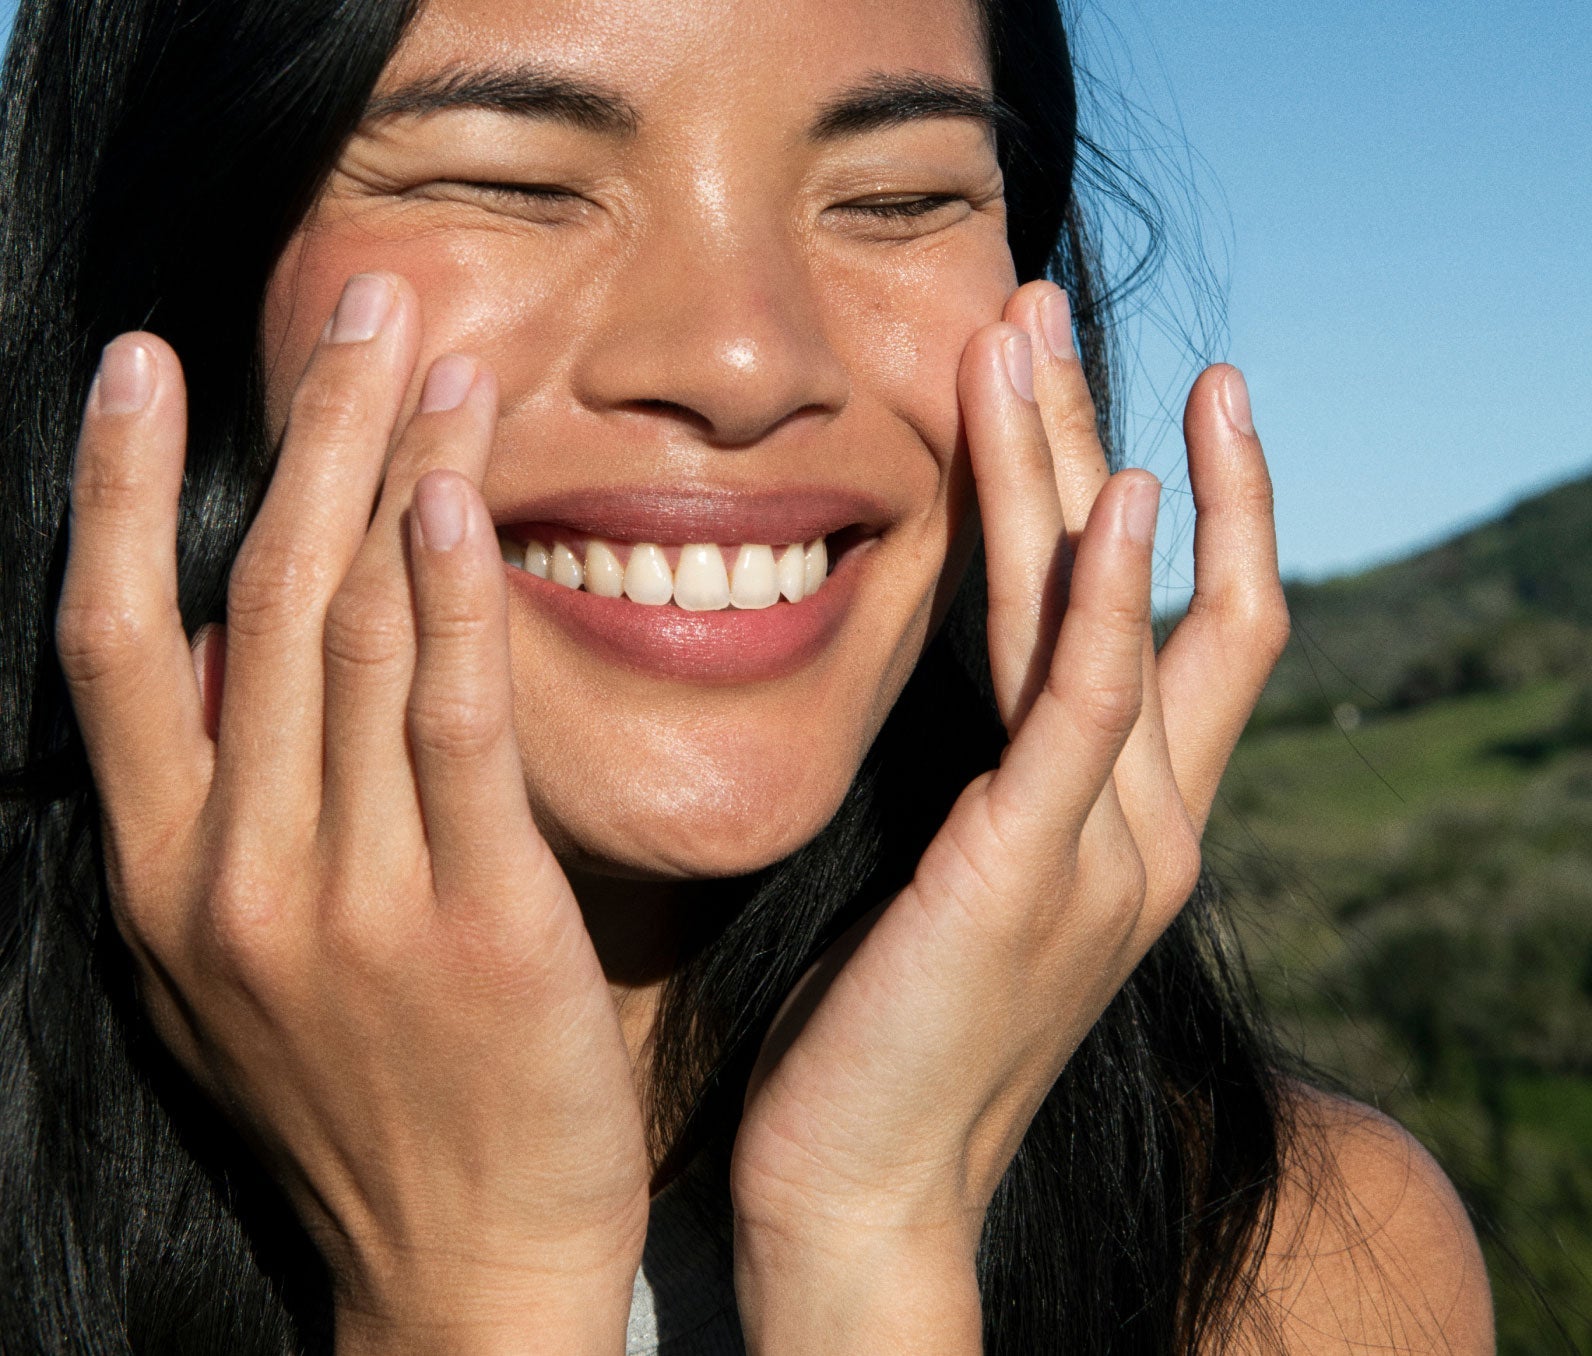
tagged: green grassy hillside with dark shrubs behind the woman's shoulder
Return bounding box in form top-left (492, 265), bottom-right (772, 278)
top-left (1207, 479), bottom-right (1592, 1356)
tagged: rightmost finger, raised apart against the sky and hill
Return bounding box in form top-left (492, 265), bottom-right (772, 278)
top-left (1159, 366), bottom-right (1288, 829)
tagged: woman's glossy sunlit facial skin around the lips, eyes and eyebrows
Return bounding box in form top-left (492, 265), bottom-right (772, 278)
top-left (263, 0), bottom-right (1016, 877)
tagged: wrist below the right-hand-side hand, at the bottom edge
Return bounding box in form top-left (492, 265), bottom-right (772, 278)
top-left (736, 1224), bottom-right (984, 1356)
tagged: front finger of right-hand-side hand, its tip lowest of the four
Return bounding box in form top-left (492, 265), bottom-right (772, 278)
top-left (989, 471), bottom-right (1161, 844)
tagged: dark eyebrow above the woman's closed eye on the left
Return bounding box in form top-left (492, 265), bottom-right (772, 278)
top-left (365, 65), bottom-right (642, 137)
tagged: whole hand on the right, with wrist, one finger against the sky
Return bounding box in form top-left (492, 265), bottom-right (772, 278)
top-left (732, 283), bottom-right (1286, 1353)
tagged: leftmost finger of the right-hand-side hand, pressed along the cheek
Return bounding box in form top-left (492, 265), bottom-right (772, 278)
top-left (957, 325), bottom-right (1068, 731)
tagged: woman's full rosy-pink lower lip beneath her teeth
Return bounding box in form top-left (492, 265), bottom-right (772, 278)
top-left (505, 543), bottom-right (869, 683)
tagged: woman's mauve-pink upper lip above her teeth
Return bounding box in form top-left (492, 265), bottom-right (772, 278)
top-left (492, 487), bottom-right (893, 544)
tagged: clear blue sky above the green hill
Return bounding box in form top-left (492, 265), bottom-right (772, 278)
top-left (0, 0), bottom-right (1592, 602)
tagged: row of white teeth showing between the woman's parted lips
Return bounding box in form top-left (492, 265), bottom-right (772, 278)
top-left (498, 524), bottom-right (864, 613)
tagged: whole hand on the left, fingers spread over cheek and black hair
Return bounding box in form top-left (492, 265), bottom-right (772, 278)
top-left (56, 275), bottom-right (648, 1351)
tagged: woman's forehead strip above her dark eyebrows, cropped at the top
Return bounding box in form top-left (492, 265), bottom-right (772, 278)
top-left (382, 0), bottom-right (989, 103)
